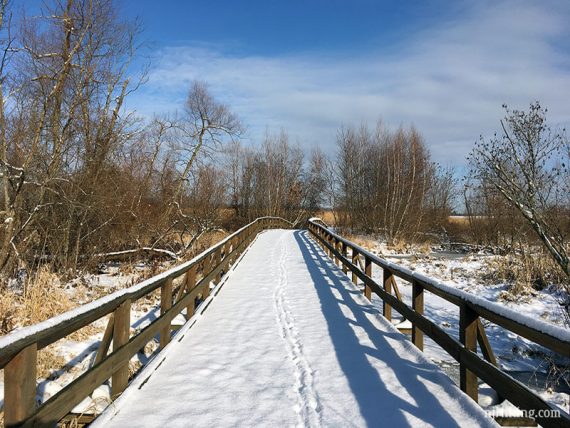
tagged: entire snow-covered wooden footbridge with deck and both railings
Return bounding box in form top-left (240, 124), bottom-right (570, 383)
top-left (0, 217), bottom-right (570, 427)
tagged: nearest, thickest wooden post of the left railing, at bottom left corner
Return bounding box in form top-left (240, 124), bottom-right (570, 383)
top-left (4, 343), bottom-right (38, 427)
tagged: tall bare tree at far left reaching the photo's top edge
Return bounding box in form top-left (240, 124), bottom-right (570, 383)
top-left (0, 0), bottom-right (146, 269)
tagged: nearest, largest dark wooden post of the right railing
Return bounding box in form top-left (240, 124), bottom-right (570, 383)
top-left (459, 304), bottom-right (479, 402)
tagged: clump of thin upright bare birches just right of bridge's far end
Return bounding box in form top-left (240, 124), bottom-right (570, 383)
top-left (337, 122), bottom-right (433, 242)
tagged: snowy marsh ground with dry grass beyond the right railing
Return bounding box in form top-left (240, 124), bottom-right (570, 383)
top-left (360, 244), bottom-right (570, 412)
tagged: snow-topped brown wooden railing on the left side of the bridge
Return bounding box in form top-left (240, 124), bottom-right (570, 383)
top-left (0, 217), bottom-right (292, 427)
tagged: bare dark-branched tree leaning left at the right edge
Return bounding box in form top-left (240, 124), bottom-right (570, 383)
top-left (469, 102), bottom-right (570, 276)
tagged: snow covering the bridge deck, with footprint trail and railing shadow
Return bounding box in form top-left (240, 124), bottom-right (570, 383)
top-left (95, 230), bottom-right (494, 427)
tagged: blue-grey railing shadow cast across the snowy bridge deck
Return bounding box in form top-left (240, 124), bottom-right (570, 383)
top-left (295, 231), bottom-right (466, 427)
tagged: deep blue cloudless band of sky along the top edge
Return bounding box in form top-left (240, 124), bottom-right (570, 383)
top-left (125, 0), bottom-right (461, 55)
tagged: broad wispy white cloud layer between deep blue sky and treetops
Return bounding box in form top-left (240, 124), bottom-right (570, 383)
top-left (126, 1), bottom-right (570, 164)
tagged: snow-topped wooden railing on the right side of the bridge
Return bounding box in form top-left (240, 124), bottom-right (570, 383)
top-left (308, 219), bottom-right (570, 427)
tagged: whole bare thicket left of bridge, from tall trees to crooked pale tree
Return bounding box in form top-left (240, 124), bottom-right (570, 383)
top-left (0, 0), bottom-right (252, 279)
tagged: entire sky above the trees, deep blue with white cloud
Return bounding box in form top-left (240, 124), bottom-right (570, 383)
top-left (117, 0), bottom-right (570, 165)
